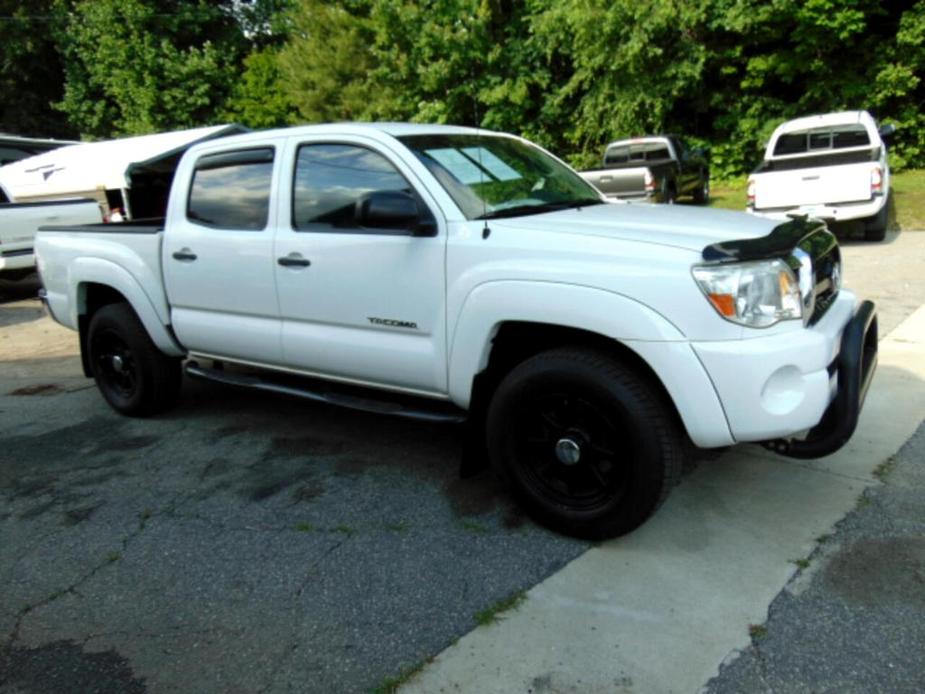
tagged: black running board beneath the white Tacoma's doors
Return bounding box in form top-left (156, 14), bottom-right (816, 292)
top-left (186, 361), bottom-right (466, 424)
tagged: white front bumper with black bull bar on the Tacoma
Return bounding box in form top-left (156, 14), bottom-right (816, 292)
top-left (691, 290), bottom-right (877, 457)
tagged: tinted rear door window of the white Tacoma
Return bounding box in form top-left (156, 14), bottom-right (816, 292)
top-left (186, 147), bottom-right (275, 231)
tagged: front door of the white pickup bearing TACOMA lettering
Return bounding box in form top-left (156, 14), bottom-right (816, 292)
top-left (275, 136), bottom-right (446, 394)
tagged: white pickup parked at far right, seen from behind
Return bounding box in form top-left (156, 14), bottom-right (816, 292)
top-left (746, 111), bottom-right (895, 241)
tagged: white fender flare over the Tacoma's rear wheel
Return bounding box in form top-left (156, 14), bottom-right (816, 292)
top-left (68, 257), bottom-right (186, 357)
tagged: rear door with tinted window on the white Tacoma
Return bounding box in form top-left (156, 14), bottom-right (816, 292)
top-left (162, 142), bottom-right (282, 364)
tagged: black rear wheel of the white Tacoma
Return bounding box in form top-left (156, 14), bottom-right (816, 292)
top-left (87, 303), bottom-right (182, 417)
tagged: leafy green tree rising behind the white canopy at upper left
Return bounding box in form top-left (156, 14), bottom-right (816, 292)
top-left (58, 0), bottom-right (246, 137)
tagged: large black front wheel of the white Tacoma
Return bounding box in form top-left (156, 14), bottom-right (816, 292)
top-left (486, 347), bottom-right (684, 539)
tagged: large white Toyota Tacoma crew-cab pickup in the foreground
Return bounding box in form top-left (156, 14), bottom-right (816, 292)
top-left (37, 124), bottom-right (877, 537)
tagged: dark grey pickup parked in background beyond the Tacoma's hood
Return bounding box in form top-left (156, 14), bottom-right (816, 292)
top-left (581, 135), bottom-right (710, 204)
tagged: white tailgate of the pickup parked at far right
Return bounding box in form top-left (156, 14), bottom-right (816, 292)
top-left (755, 162), bottom-right (873, 210)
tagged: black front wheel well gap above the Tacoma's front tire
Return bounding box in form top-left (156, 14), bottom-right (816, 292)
top-left (470, 321), bottom-right (686, 431)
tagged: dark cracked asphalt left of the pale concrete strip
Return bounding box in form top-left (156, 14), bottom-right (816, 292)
top-left (0, 278), bottom-right (587, 694)
